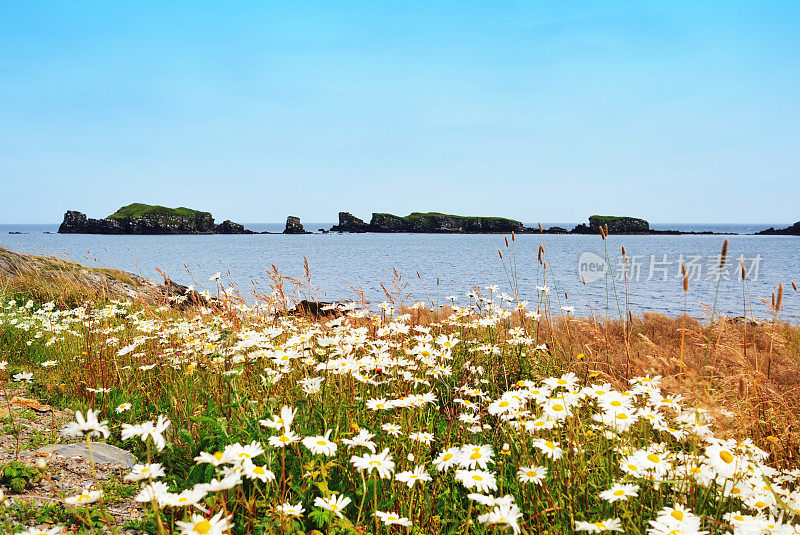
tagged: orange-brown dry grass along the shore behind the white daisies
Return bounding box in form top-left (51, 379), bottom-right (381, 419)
top-left (382, 307), bottom-right (800, 466)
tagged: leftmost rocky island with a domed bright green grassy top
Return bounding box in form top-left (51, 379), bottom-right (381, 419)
top-left (58, 203), bottom-right (253, 234)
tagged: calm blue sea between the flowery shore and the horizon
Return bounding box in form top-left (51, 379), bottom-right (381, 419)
top-left (0, 223), bottom-right (800, 323)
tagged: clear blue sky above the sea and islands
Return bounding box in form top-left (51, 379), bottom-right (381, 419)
top-left (0, 0), bottom-right (800, 223)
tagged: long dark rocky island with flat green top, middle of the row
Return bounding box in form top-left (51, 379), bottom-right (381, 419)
top-left (331, 212), bottom-right (531, 234)
